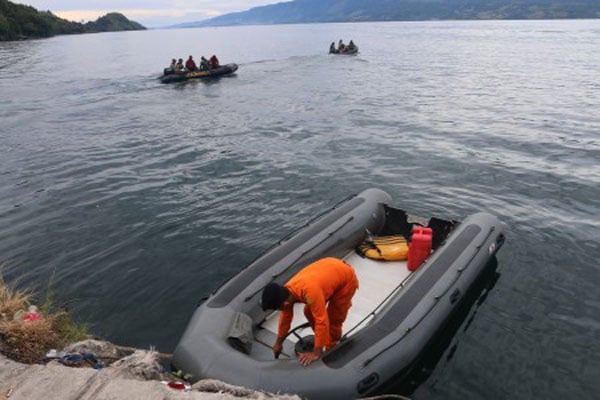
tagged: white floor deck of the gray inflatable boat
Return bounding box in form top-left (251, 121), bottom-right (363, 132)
top-left (262, 251), bottom-right (412, 342)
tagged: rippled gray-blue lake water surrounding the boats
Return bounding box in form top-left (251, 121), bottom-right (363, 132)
top-left (0, 20), bottom-right (600, 400)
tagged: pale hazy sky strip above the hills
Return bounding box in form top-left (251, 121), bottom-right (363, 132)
top-left (11, 0), bottom-right (286, 28)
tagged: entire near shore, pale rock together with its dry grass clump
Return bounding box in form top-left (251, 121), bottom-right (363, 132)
top-left (0, 282), bottom-right (406, 400)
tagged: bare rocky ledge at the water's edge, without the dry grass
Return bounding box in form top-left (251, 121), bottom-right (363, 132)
top-left (0, 340), bottom-right (300, 400)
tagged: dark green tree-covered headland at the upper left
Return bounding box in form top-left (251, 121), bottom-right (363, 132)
top-left (0, 0), bottom-right (146, 41)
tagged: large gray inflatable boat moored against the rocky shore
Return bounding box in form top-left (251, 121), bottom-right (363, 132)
top-left (173, 189), bottom-right (504, 399)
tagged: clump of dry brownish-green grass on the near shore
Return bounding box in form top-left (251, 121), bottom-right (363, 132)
top-left (0, 276), bottom-right (88, 364)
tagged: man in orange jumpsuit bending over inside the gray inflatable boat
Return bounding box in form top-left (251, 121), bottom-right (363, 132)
top-left (261, 257), bottom-right (358, 366)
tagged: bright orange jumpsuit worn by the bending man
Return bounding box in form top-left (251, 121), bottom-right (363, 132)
top-left (277, 257), bottom-right (358, 349)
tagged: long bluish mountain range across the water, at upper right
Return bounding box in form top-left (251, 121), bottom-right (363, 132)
top-left (173, 0), bottom-right (600, 28)
